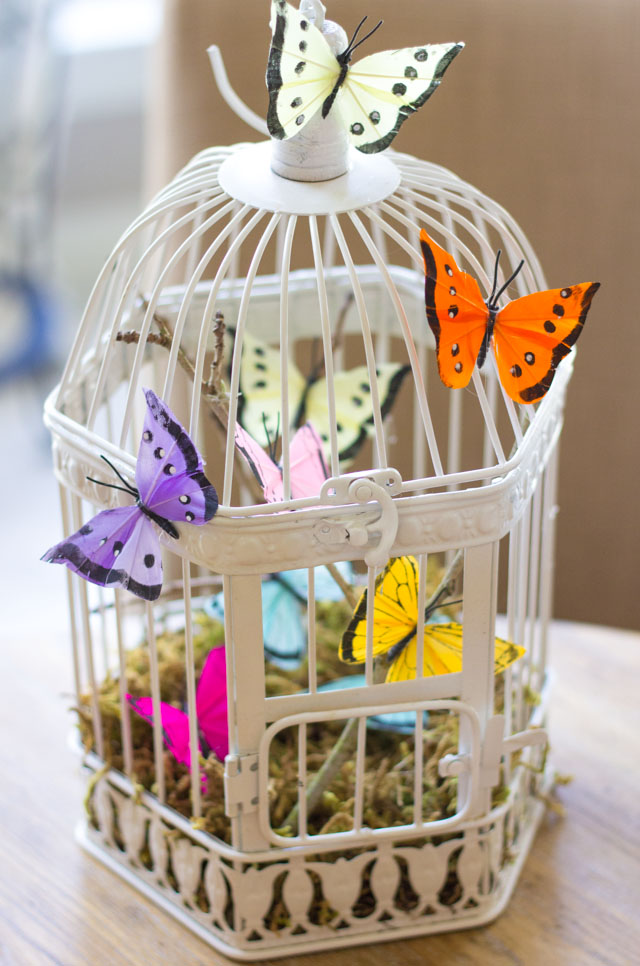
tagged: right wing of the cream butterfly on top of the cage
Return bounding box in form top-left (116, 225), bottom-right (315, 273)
top-left (338, 44), bottom-right (464, 154)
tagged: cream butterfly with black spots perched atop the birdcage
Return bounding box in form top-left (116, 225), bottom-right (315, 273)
top-left (267, 0), bottom-right (464, 154)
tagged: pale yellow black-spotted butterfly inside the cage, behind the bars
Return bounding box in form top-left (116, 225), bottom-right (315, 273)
top-left (238, 332), bottom-right (410, 461)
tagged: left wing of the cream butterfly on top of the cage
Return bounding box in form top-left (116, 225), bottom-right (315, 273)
top-left (267, 0), bottom-right (340, 140)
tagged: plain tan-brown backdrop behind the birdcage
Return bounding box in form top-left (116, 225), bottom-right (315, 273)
top-left (148, 0), bottom-right (640, 628)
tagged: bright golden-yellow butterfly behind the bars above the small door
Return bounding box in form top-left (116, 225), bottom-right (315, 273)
top-left (339, 557), bottom-right (525, 681)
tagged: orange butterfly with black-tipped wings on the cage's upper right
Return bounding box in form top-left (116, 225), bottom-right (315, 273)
top-left (420, 229), bottom-right (600, 403)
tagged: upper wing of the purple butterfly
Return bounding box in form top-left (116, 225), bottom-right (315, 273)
top-left (136, 389), bottom-right (218, 526)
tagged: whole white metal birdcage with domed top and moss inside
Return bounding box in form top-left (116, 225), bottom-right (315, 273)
top-left (46, 7), bottom-right (571, 959)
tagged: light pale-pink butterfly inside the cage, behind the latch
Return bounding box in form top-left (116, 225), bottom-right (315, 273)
top-left (235, 423), bottom-right (329, 503)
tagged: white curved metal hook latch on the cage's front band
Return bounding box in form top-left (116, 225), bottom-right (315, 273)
top-left (315, 468), bottom-right (402, 567)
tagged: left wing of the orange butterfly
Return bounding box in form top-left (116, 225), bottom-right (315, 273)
top-left (420, 229), bottom-right (489, 389)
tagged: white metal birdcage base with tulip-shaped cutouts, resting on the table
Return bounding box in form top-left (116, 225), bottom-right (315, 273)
top-left (76, 765), bottom-right (551, 961)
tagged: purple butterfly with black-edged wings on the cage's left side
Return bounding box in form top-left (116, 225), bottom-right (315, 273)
top-left (42, 389), bottom-right (218, 600)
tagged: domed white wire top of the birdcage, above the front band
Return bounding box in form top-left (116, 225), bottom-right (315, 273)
top-left (46, 136), bottom-right (570, 576)
